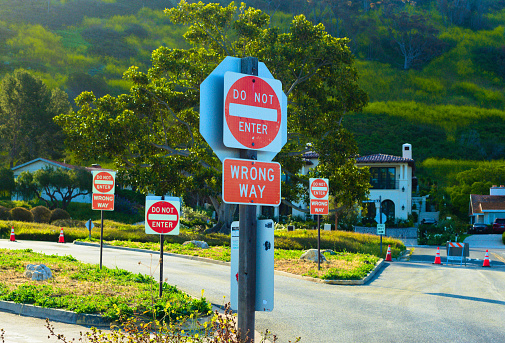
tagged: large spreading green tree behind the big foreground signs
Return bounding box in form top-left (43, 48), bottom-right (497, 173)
top-left (56, 1), bottom-right (368, 232)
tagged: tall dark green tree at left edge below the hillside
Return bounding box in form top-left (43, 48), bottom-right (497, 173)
top-left (0, 69), bottom-right (70, 168)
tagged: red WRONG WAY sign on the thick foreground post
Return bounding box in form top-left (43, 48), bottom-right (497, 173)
top-left (223, 158), bottom-right (281, 206)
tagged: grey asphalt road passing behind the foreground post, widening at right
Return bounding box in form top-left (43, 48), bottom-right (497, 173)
top-left (0, 240), bottom-right (505, 343)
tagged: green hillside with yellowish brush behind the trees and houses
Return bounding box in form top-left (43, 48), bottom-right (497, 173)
top-left (0, 0), bottom-right (505, 196)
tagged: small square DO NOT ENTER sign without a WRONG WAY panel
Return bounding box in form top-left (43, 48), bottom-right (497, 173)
top-left (145, 200), bottom-right (180, 235)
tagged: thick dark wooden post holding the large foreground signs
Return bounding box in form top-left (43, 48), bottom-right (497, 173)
top-left (237, 57), bottom-right (258, 342)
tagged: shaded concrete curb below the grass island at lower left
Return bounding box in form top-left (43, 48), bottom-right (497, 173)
top-left (0, 300), bottom-right (110, 328)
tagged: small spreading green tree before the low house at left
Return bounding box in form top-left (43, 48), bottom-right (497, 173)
top-left (16, 167), bottom-right (92, 209)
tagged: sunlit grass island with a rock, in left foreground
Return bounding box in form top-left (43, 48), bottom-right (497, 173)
top-left (0, 249), bottom-right (210, 321)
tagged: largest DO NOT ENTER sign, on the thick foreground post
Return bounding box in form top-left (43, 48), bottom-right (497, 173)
top-left (223, 72), bottom-right (282, 151)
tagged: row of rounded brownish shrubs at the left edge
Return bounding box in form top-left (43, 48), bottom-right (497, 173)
top-left (0, 206), bottom-right (70, 224)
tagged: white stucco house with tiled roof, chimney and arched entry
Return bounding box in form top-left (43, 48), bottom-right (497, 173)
top-left (356, 143), bottom-right (417, 220)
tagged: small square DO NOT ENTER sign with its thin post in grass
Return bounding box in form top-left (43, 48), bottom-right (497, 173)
top-left (145, 196), bottom-right (181, 298)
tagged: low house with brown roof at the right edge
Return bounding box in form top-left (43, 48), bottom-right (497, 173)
top-left (469, 185), bottom-right (505, 225)
